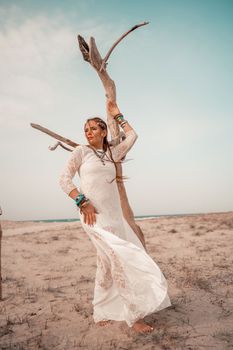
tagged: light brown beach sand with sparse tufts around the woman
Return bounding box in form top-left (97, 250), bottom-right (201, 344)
top-left (0, 212), bottom-right (233, 350)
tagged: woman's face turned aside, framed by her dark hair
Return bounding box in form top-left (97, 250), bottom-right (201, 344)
top-left (84, 120), bottom-right (106, 148)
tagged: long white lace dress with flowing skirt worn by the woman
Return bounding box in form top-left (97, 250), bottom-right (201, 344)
top-left (59, 130), bottom-right (171, 327)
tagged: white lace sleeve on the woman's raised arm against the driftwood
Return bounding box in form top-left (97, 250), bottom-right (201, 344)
top-left (111, 129), bottom-right (138, 162)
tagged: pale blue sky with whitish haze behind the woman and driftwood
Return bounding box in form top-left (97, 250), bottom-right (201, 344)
top-left (0, 0), bottom-right (233, 220)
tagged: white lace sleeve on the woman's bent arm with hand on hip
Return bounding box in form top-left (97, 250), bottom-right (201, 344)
top-left (59, 146), bottom-right (82, 195)
